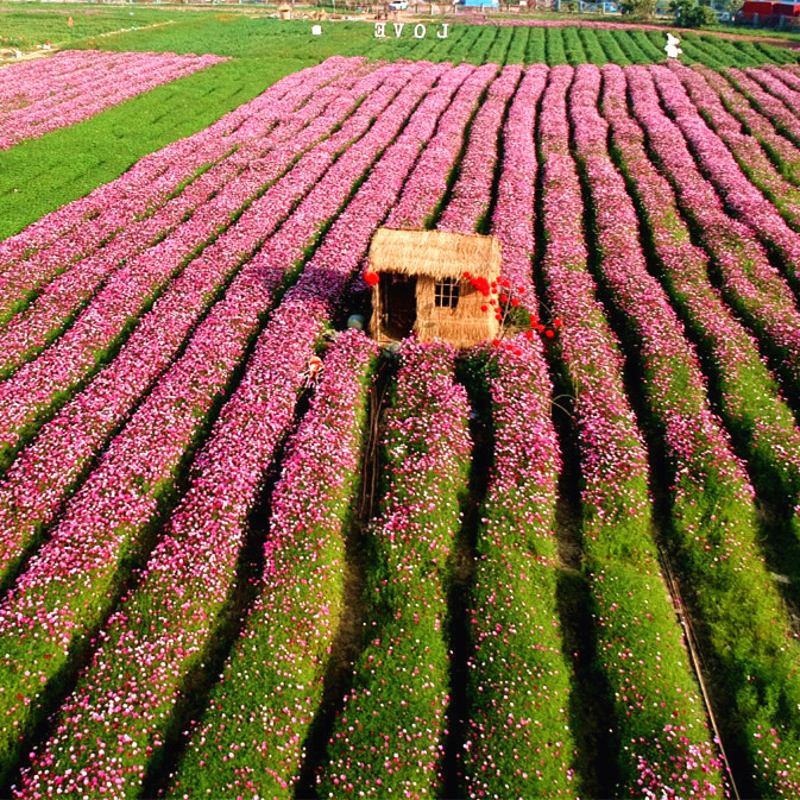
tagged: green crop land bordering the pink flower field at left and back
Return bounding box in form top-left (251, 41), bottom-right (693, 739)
top-left (0, 7), bottom-right (797, 239)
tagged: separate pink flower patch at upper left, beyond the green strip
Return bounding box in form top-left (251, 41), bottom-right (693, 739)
top-left (0, 50), bottom-right (223, 150)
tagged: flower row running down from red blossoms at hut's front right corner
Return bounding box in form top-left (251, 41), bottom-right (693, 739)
top-left (462, 346), bottom-right (578, 797)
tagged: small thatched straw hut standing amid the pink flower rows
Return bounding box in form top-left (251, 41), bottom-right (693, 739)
top-left (369, 228), bottom-right (501, 347)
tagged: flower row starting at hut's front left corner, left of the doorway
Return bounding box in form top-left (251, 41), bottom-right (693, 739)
top-left (170, 332), bottom-right (375, 798)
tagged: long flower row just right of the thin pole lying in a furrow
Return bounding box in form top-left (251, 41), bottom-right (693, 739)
top-left (570, 68), bottom-right (800, 794)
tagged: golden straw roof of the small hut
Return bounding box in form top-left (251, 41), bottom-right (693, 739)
top-left (369, 228), bottom-right (501, 280)
